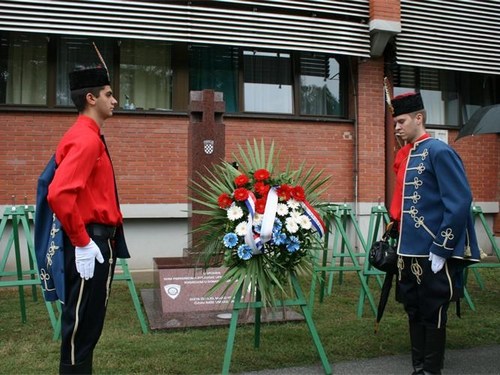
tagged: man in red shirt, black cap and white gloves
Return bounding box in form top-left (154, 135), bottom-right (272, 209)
top-left (47, 68), bottom-right (129, 374)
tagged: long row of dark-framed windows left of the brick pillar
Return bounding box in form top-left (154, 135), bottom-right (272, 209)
top-left (0, 32), bottom-right (352, 117)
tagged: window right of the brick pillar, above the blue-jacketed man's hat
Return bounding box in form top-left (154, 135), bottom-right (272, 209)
top-left (394, 65), bottom-right (500, 127)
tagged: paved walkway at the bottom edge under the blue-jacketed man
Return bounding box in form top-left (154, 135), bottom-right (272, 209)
top-left (241, 345), bottom-right (500, 375)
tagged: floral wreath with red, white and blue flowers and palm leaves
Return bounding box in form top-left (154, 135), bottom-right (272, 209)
top-left (191, 140), bottom-right (328, 306)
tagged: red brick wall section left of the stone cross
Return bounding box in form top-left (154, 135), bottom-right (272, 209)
top-left (0, 112), bottom-right (187, 204)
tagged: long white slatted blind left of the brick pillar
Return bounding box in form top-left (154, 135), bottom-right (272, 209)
top-left (0, 0), bottom-right (370, 57)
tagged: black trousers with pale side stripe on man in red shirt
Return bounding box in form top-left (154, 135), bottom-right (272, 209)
top-left (60, 231), bottom-right (116, 373)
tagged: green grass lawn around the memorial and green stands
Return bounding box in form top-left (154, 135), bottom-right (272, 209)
top-left (0, 269), bottom-right (500, 374)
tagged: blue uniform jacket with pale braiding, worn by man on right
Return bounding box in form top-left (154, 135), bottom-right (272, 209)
top-left (398, 138), bottom-right (480, 263)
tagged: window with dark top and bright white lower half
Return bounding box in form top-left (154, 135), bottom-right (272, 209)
top-left (243, 51), bottom-right (293, 113)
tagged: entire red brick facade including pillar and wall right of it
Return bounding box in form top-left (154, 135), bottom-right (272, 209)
top-left (0, 59), bottom-right (500, 232)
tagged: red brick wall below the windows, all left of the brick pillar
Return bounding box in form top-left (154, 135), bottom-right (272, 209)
top-left (0, 112), bottom-right (354, 204)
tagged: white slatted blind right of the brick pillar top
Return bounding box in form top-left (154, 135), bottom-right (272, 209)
top-left (396, 0), bottom-right (500, 74)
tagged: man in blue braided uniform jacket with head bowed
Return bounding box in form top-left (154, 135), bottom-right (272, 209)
top-left (390, 93), bottom-right (480, 374)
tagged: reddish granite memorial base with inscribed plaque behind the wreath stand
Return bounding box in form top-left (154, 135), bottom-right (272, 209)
top-left (141, 257), bottom-right (304, 330)
